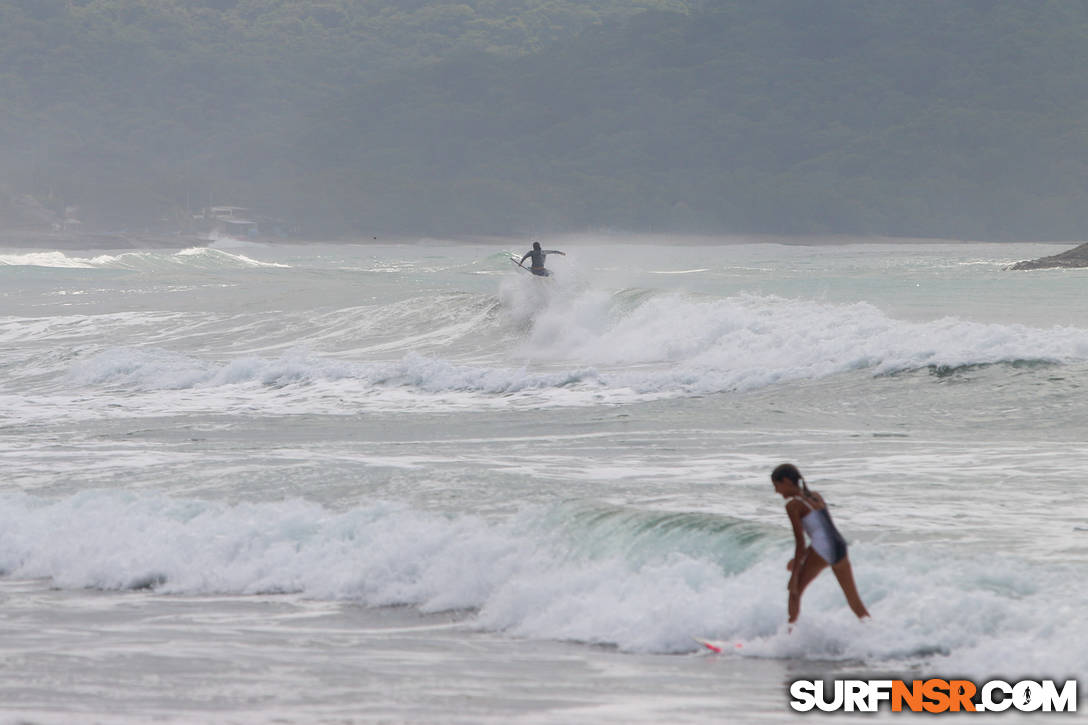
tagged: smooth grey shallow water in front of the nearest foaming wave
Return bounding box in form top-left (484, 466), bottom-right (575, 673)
top-left (0, 578), bottom-right (809, 725)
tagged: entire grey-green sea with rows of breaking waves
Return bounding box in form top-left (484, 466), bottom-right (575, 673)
top-left (0, 237), bottom-right (1088, 725)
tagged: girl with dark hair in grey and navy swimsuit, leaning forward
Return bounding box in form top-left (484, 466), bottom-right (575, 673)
top-left (770, 464), bottom-right (869, 624)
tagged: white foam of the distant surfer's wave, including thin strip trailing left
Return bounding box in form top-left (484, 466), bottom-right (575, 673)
top-left (57, 290), bottom-right (1088, 403)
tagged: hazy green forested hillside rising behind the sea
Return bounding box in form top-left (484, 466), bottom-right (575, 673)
top-left (6, 0), bottom-right (1088, 239)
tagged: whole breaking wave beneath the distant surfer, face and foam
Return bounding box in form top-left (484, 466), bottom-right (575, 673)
top-left (8, 276), bottom-right (1088, 410)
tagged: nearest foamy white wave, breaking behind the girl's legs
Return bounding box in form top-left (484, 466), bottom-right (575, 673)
top-left (0, 491), bottom-right (1088, 678)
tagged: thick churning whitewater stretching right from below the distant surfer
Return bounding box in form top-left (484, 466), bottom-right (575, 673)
top-left (513, 291), bottom-right (1088, 392)
